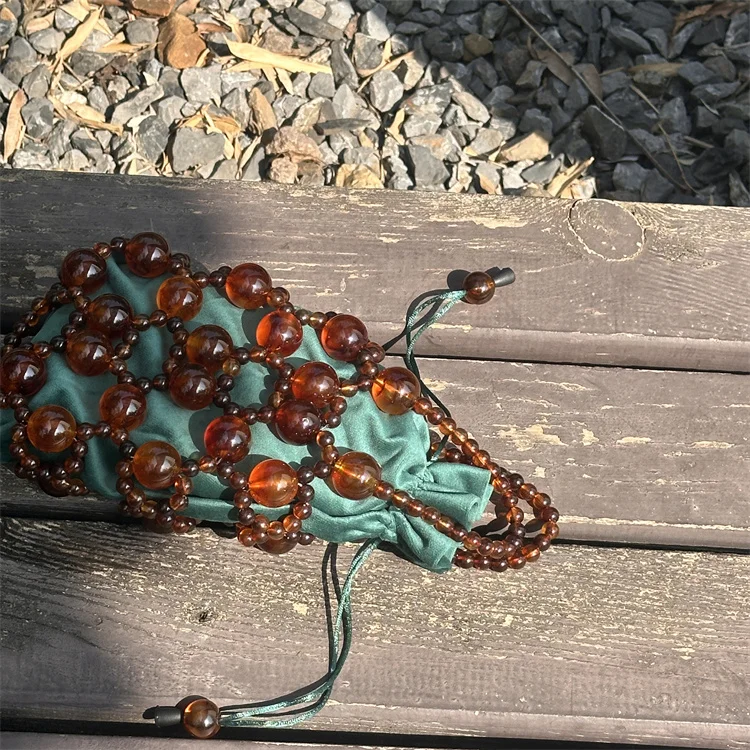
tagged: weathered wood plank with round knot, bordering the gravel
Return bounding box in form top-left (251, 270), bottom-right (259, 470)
top-left (0, 171), bottom-right (750, 371)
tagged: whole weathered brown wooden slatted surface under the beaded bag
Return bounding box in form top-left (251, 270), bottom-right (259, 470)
top-left (0, 171), bottom-right (750, 750)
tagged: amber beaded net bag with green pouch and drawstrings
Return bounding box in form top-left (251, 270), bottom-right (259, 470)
top-left (0, 233), bottom-right (558, 737)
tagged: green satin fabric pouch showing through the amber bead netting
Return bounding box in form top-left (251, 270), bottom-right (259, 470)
top-left (0, 258), bottom-right (492, 572)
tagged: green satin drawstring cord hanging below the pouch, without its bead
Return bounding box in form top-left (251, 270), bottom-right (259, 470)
top-left (219, 539), bottom-right (379, 728)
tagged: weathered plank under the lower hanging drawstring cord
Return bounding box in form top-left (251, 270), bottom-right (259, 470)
top-left (2, 519), bottom-right (750, 748)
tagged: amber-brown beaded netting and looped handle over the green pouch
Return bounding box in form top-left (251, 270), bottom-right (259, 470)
top-left (0, 233), bottom-right (559, 572)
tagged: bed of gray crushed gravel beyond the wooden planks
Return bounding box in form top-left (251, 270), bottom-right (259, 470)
top-left (0, 0), bottom-right (750, 206)
